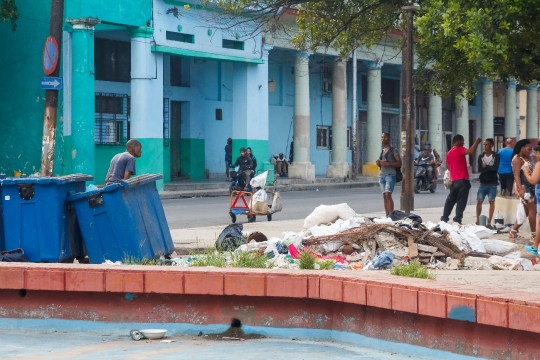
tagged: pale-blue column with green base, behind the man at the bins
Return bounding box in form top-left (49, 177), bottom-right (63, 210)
top-left (130, 27), bottom-right (164, 190)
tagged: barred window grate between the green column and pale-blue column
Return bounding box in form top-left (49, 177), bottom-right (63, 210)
top-left (94, 93), bottom-right (129, 145)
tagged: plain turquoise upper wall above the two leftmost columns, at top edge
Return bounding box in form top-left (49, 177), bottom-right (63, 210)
top-left (64, 0), bottom-right (152, 26)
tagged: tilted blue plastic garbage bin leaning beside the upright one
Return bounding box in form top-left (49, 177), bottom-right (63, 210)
top-left (69, 174), bottom-right (174, 264)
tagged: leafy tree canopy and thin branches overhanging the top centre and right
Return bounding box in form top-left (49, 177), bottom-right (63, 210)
top-left (210, 0), bottom-right (540, 96)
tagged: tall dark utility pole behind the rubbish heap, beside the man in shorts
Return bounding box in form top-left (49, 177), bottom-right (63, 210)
top-left (401, 4), bottom-right (420, 213)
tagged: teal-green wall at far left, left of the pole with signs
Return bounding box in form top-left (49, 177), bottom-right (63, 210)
top-left (0, 1), bottom-right (54, 175)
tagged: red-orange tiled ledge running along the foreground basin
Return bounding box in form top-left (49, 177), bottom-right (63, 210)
top-left (0, 263), bottom-right (540, 333)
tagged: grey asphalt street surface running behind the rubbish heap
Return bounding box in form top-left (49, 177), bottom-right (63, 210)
top-left (163, 182), bottom-right (479, 229)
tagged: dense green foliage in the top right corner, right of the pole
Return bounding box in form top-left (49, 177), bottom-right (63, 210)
top-left (415, 0), bottom-right (540, 98)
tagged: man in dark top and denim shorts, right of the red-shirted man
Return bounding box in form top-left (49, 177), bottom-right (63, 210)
top-left (476, 139), bottom-right (500, 228)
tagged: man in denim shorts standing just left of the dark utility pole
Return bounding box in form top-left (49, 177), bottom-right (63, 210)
top-left (375, 132), bottom-right (402, 216)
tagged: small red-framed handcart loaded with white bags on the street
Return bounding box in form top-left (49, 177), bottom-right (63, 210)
top-left (229, 171), bottom-right (283, 224)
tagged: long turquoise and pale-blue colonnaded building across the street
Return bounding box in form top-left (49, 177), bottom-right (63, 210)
top-left (0, 0), bottom-right (538, 186)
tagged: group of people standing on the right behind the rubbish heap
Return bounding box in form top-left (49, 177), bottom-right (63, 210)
top-left (376, 132), bottom-right (540, 254)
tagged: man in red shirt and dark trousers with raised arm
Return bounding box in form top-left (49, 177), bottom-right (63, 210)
top-left (441, 135), bottom-right (481, 224)
